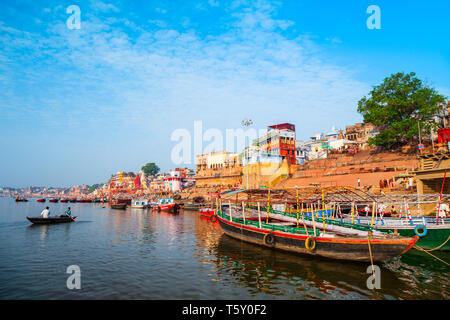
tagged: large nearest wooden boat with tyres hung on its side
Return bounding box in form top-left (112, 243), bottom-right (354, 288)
top-left (217, 208), bottom-right (419, 262)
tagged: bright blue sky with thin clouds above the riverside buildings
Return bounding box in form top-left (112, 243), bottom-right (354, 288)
top-left (0, 0), bottom-right (450, 186)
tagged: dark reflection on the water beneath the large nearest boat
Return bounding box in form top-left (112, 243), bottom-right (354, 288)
top-left (216, 235), bottom-right (430, 299)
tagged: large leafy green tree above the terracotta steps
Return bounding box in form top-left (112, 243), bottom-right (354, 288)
top-left (358, 72), bottom-right (445, 148)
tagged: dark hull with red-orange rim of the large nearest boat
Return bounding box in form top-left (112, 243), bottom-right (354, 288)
top-left (218, 217), bottom-right (418, 262)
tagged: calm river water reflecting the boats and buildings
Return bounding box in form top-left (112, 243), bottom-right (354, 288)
top-left (0, 198), bottom-right (450, 299)
